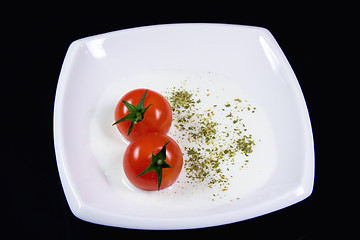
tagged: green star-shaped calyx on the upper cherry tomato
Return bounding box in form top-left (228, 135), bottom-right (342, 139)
top-left (113, 90), bottom-right (152, 136)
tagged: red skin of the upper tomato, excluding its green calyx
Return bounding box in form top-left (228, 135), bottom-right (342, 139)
top-left (115, 89), bottom-right (172, 142)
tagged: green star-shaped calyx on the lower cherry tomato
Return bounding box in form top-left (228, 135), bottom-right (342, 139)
top-left (137, 142), bottom-right (171, 190)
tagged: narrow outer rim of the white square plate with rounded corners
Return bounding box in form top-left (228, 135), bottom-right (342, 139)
top-left (53, 23), bottom-right (315, 230)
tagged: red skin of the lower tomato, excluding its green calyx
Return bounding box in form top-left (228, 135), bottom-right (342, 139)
top-left (123, 133), bottom-right (183, 191)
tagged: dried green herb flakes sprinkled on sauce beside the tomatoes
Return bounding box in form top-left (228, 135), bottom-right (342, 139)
top-left (164, 82), bottom-right (256, 197)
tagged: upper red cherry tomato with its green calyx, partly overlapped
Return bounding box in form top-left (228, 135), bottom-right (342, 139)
top-left (114, 89), bottom-right (172, 142)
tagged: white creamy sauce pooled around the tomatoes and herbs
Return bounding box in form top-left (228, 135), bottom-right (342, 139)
top-left (90, 71), bottom-right (277, 209)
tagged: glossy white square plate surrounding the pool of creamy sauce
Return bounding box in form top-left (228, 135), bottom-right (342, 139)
top-left (54, 24), bottom-right (314, 229)
